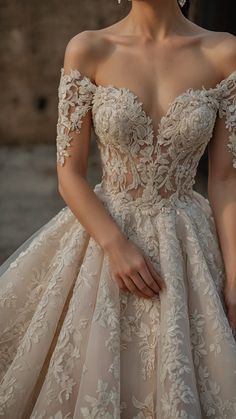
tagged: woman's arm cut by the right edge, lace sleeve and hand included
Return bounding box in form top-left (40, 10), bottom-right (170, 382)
top-left (208, 44), bottom-right (236, 329)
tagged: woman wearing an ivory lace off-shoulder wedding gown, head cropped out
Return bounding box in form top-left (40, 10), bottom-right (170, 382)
top-left (0, 0), bottom-right (236, 419)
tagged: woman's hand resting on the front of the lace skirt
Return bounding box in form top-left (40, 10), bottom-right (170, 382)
top-left (104, 235), bottom-right (166, 298)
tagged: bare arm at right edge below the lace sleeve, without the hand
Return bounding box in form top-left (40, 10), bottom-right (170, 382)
top-left (208, 130), bottom-right (236, 286)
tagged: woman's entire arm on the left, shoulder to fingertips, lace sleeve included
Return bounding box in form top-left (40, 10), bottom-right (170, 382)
top-left (57, 31), bottom-right (165, 297)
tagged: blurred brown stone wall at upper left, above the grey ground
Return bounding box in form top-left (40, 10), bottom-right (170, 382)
top-left (0, 0), bottom-right (130, 144)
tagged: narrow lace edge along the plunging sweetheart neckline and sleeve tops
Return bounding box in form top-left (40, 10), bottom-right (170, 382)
top-left (61, 67), bottom-right (236, 139)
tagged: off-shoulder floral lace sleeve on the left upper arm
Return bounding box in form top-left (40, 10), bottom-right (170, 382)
top-left (56, 68), bottom-right (96, 166)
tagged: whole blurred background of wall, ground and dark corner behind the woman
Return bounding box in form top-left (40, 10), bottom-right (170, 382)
top-left (0, 0), bottom-right (236, 263)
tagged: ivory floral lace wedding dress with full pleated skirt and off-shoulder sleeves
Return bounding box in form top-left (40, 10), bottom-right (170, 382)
top-left (0, 68), bottom-right (236, 419)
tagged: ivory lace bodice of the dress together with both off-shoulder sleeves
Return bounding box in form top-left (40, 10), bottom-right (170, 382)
top-left (54, 68), bottom-right (236, 215)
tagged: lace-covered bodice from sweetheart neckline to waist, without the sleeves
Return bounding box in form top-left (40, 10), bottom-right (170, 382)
top-left (92, 86), bottom-right (218, 217)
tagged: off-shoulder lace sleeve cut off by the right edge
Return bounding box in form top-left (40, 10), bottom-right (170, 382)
top-left (219, 71), bottom-right (236, 169)
